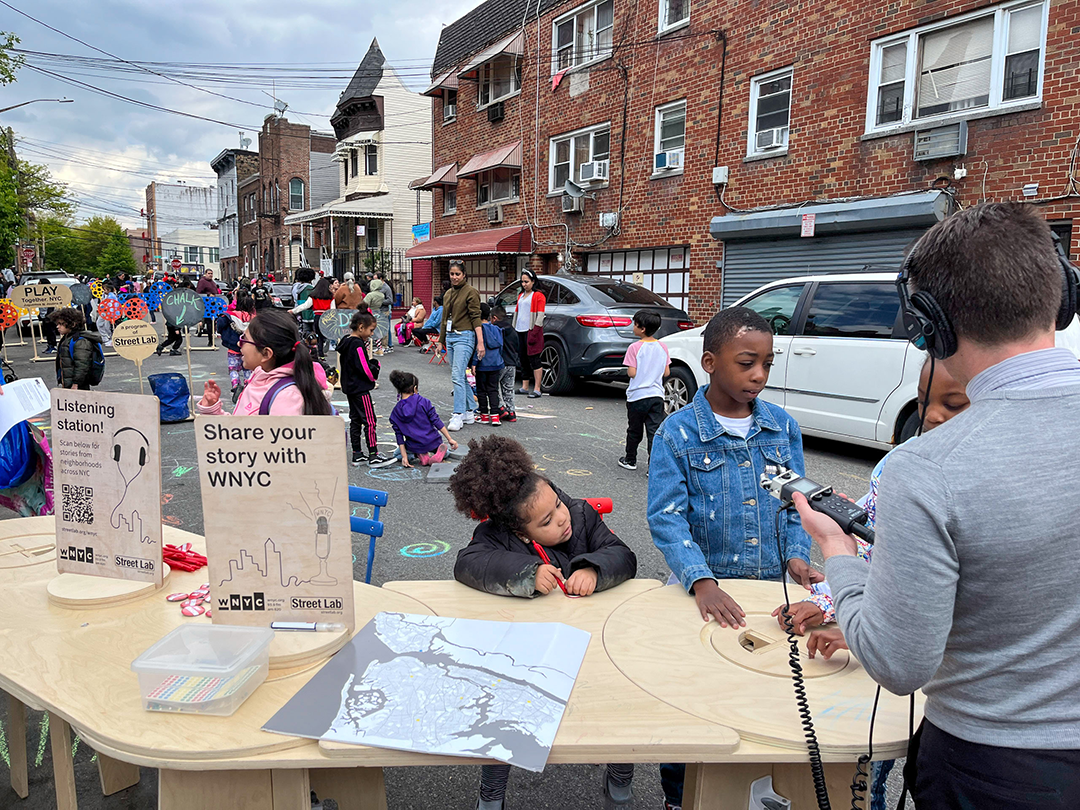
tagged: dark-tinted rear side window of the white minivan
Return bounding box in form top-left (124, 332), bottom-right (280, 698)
top-left (802, 283), bottom-right (900, 338)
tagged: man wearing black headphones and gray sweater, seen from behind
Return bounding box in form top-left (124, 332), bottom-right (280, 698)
top-left (796, 203), bottom-right (1080, 810)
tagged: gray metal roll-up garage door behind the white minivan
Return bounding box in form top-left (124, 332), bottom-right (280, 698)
top-left (721, 228), bottom-right (926, 307)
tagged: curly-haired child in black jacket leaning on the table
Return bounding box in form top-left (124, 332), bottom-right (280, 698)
top-left (450, 436), bottom-right (637, 810)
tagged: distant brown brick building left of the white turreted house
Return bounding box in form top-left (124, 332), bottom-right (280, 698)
top-left (237, 116), bottom-right (339, 278)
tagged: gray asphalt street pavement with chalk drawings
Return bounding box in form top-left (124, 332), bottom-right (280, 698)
top-left (0, 322), bottom-right (882, 810)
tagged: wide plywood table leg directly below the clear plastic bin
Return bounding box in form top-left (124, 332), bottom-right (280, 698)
top-left (158, 769), bottom-right (276, 810)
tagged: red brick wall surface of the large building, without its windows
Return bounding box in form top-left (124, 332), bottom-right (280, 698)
top-left (432, 0), bottom-right (1080, 322)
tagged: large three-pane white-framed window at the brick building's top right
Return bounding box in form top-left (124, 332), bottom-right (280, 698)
top-left (866, 2), bottom-right (1047, 132)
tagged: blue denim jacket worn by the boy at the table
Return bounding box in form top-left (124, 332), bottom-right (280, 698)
top-left (648, 386), bottom-right (810, 591)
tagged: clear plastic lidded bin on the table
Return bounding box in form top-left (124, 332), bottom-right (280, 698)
top-left (132, 624), bottom-right (273, 717)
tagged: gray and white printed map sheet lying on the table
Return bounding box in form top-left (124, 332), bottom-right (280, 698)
top-left (262, 613), bottom-right (590, 771)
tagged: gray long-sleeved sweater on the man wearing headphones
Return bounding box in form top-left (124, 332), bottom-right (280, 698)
top-left (825, 349), bottom-right (1080, 748)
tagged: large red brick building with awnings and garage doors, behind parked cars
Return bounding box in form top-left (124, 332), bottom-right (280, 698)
top-left (410, 0), bottom-right (1080, 321)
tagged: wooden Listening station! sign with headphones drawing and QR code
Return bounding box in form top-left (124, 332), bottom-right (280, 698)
top-left (52, 388), bottom-right (163, 585)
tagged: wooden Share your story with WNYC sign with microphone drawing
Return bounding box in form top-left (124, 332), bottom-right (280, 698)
top-left (195, 416), bottom-right (355, 631)
